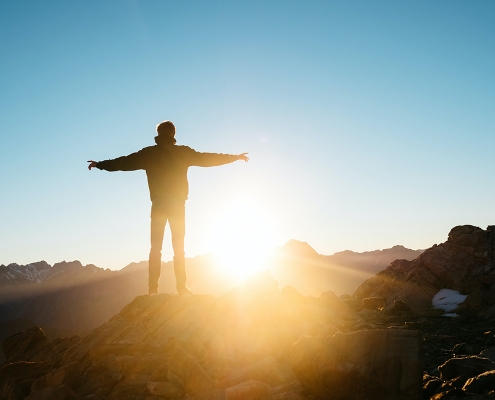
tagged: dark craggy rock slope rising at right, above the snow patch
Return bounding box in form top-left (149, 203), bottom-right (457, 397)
top-left (354, 225), bottom-right (495, 319)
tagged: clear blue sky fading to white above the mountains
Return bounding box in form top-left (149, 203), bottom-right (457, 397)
top-left (0, 0), bottom-right (495, 269)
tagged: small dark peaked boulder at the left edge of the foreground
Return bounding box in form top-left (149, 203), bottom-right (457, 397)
top-left (2, 325), bottom-right (49, 363)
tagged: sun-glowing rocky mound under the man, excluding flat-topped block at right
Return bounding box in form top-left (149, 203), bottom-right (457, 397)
top-left (0, 271), bottom-right (386, 400)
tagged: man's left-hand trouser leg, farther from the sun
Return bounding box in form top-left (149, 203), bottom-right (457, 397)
top-left (148, 203), bottom-right (167, 293)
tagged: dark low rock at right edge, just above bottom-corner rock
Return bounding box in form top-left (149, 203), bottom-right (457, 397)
top-left (438, 357), bottom-right (495, 387)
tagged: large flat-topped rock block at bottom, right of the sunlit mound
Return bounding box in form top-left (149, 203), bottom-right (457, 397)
top-left (291, 330), bottom-right (422, 400)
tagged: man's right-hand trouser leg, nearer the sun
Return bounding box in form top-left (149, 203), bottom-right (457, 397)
top-left (169, 202), bottom-right (186, 291)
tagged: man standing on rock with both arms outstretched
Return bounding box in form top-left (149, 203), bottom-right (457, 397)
top-left (88, 121), bottom-right (249, 296)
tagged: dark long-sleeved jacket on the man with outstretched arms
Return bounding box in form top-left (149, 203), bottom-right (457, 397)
top-left (96, 143), bottom-right (237, 201)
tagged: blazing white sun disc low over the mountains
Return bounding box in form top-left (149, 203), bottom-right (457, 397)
top-left (211, 202), bottom-right (276, 283)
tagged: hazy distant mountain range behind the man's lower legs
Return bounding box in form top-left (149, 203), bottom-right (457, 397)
top-left (0, 241), bottom-right (420, 346)
